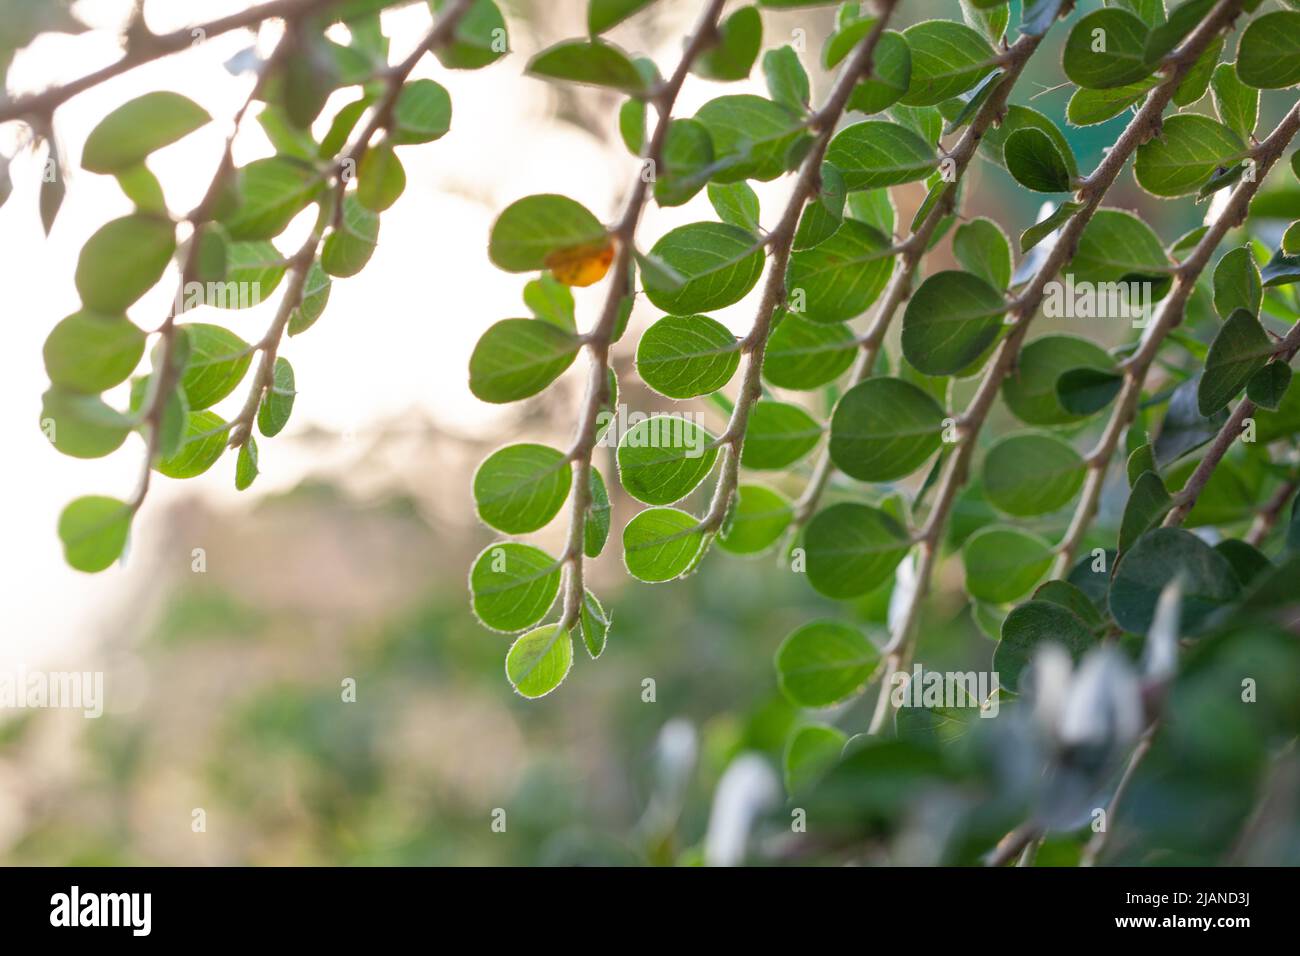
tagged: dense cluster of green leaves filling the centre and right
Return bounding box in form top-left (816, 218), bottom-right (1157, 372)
top-left (469, 0), bottom-right (1300, 863)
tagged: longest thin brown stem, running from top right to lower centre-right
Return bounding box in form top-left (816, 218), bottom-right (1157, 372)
top-left (868, 0), bottom-right (1243, 734)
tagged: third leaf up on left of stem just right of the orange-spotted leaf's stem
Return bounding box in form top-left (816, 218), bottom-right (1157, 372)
top-left (637, 315), bottom-right (740, 398)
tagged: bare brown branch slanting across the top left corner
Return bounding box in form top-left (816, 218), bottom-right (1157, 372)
top-left (0, 0), bottom-right (339, 124)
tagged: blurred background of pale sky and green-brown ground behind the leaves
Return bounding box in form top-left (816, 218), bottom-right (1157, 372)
top-left (0, 0), bottom-right (1286, 865)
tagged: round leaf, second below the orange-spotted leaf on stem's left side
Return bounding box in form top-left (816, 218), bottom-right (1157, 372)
top-left (473, 445), bottom-right (573, 535)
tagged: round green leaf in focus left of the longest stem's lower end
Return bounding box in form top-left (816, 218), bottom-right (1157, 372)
top-left (776, 620), bottom-right (880, 708)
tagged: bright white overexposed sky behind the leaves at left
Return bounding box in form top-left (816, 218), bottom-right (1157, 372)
top-left (0, 0), bottom-right (788, 669)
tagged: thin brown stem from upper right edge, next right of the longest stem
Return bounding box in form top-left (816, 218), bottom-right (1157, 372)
top-left (1052, 98), bottom-right (1300, 578)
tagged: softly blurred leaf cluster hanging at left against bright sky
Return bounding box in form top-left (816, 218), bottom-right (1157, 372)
top-left (21, 0), bottom-right (506, 571)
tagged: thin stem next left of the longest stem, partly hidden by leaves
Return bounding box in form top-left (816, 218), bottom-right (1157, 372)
top-left (789, 29), bottom-right (1043, 535)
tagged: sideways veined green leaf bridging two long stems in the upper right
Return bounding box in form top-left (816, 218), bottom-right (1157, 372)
top-left (1134, 113), bottom-right (1245, 198)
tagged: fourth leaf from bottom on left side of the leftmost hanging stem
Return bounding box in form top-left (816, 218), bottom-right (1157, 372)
top-left (75, 213), bottom-right (176, 315)
